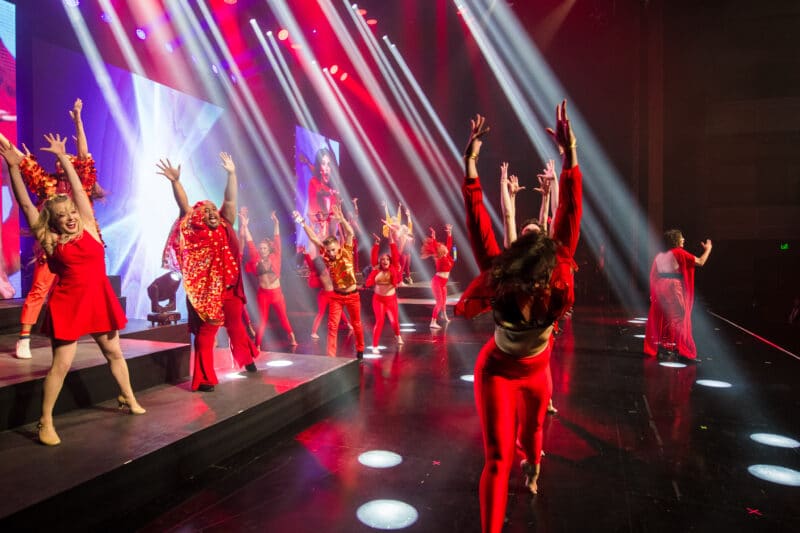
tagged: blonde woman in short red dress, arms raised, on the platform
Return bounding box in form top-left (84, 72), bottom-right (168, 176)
top-left (0, 135), bottom-right (145, 446)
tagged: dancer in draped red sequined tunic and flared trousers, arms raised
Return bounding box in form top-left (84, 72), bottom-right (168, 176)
top-left (157, 152), bottom-right (258, 392)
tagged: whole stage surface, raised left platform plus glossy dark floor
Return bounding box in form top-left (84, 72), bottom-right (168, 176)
top-left (0, 306), bottom-right (800, 532)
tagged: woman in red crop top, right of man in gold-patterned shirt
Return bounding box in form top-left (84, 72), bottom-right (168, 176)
top-left (364, 232), bottom-right (403, 353)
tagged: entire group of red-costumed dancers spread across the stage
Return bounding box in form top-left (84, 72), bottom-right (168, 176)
top-left (0, 95), bottom-right (711, 532)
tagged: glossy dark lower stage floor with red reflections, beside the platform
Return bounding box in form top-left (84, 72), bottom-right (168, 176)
top-left (108, 307), bottom-right (800, 532)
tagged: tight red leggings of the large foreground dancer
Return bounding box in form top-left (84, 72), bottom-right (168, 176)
top-left (475, 337), bottom-right (553, 533)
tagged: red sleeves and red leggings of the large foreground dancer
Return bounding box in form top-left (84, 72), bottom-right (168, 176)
top-left (455, 166), bottom-right (582, 532)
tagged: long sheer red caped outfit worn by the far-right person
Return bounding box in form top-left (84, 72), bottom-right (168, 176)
top-left (644, 248), bottom-right (697, 359)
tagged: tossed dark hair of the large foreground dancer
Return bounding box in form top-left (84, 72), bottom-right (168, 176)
top-left (489, 232), bottom-right (556, 322)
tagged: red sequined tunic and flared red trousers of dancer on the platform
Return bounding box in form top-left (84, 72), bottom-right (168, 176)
top-left (165, 202), bottom-right (258, 390)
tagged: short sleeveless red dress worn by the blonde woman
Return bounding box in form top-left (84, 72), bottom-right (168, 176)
top-left (45, 231), bottom-right (127, 341)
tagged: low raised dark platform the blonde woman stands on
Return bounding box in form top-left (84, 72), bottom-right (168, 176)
top-left (0, 352), bottom-right (359, 531)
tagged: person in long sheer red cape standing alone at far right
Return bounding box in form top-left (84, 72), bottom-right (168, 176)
top-left (644, 229), bottom-right (712, 363)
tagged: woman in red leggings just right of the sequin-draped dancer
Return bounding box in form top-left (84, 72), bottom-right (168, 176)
top-left (239, 208), bottom-right (297, 348)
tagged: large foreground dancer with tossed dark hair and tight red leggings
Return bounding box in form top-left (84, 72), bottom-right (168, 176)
top-left (456, 101), bottom-right (582, 533)
